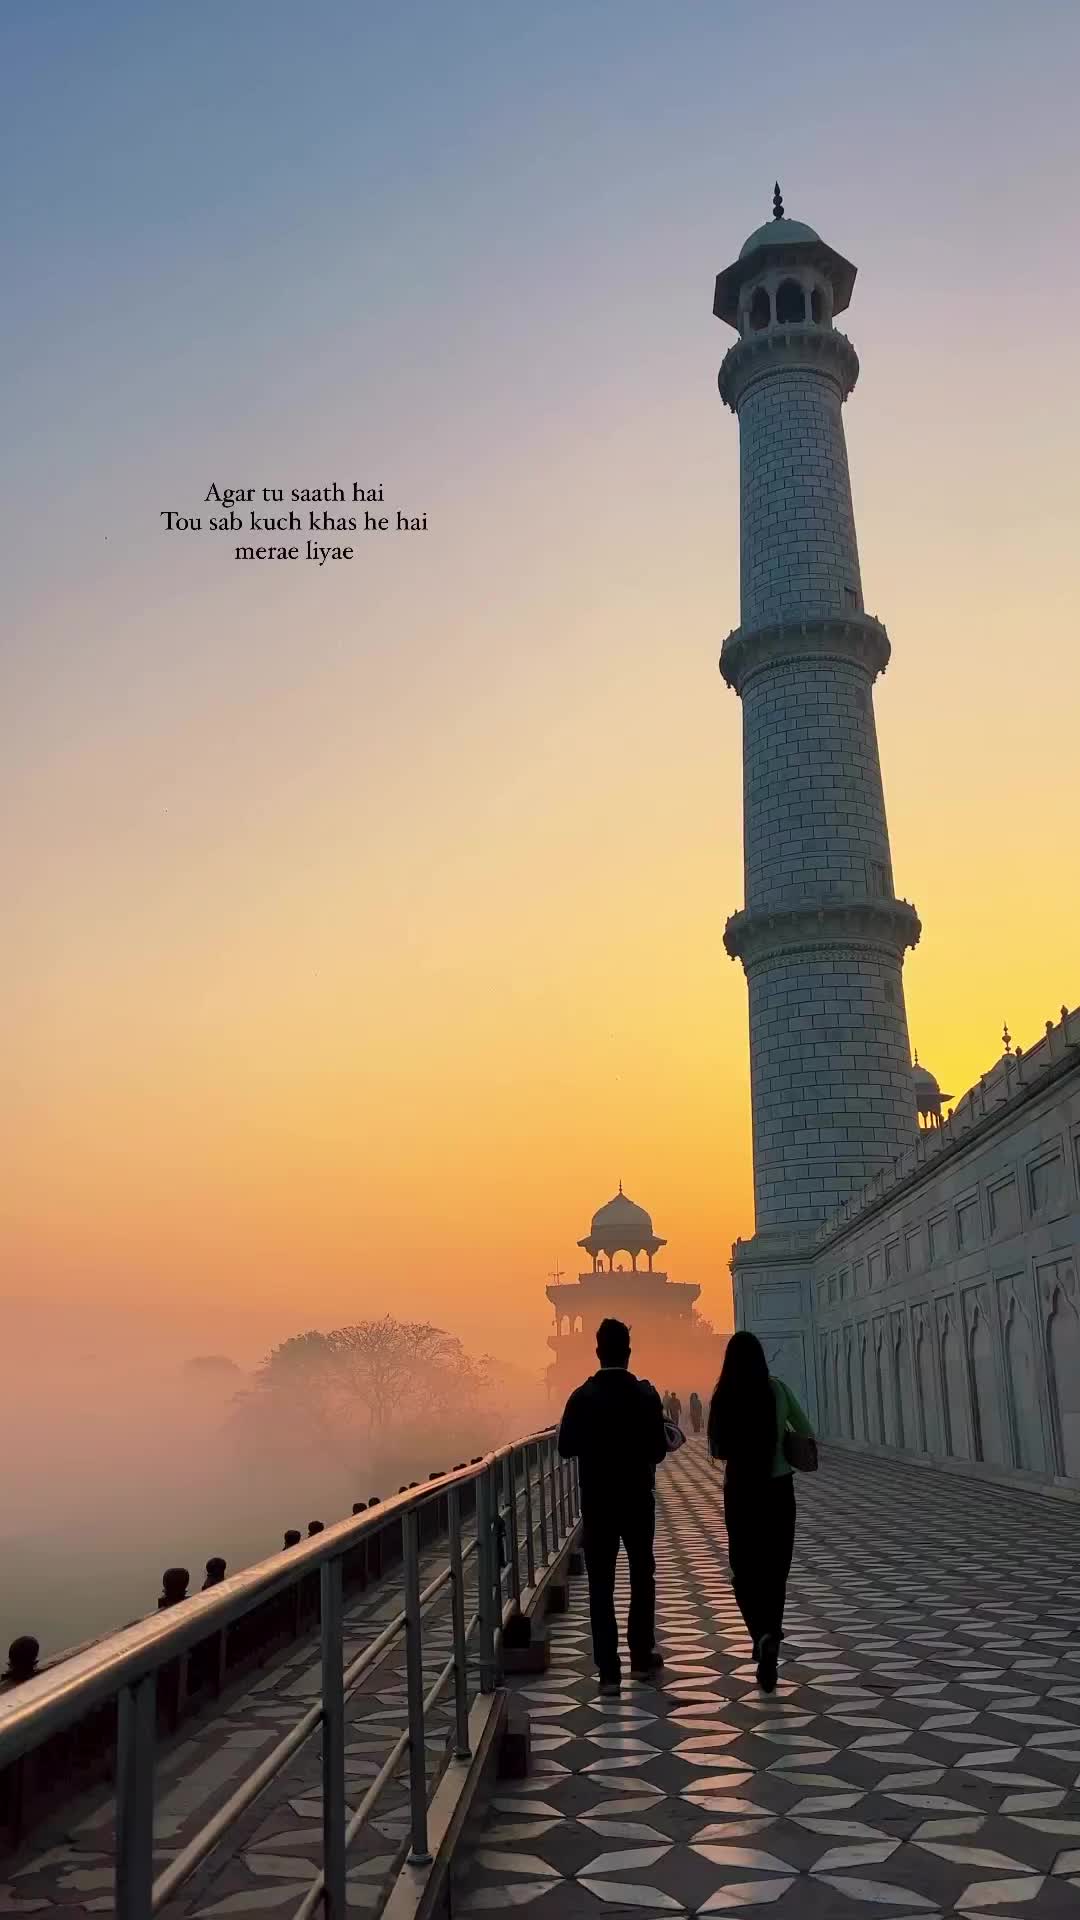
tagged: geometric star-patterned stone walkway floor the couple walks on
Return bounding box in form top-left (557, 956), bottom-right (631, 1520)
top-left (452, 1442), bottom-right (1080, 1920)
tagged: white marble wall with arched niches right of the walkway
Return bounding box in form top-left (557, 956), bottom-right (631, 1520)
top-left (811, 1048), bottom-right (1080, 1488)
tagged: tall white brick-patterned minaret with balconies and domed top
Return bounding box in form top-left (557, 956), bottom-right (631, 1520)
top-left (713, 188), bottom-right (920, 1267)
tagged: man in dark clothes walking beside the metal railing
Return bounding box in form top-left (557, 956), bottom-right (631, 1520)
top-left (559, 1319), bottom-right (667, 1695)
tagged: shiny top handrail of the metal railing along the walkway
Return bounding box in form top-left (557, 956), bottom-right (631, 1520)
top-left (0, 1427), bottom-right (555, 1766)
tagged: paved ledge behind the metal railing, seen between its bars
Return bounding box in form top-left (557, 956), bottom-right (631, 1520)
top-left (0, 1526), bottom-right (477, 1920)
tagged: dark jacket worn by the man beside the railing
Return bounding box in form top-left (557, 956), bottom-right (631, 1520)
top-left (559, 1367), bottom-right (667, 1511)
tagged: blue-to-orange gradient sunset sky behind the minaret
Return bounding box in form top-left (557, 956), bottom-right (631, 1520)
top-left (0, 0), bottom-right (1080, 1365)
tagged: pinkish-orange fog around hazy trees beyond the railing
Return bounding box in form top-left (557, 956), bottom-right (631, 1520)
top-left (0, 1304), bottom-right (544, 1665)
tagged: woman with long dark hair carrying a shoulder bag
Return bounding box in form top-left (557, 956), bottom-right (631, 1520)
top-left (709, 1332), bottom-right (817, 1693)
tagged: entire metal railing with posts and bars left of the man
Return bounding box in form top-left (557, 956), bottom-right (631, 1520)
top-left (0, 1428), bottom-right (580, 1920)
